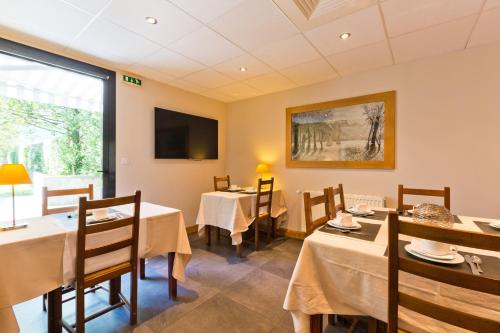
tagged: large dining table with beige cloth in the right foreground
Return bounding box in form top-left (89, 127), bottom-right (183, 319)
top-left (283, 207), bottom-right (500, 333)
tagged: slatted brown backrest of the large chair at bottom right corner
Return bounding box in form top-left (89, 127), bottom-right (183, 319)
top-left (388, 212), bottom-right (500, 333)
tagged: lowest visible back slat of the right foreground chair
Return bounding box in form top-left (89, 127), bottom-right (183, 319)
top-left (399, 292), bottom-right (500, 333)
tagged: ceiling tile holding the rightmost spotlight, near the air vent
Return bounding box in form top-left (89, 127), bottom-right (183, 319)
top-left (305, 6), bottom-right (385, 56)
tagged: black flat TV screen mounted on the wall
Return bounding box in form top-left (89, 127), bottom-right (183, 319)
top-left (155, 108), bottom-right (219, 160)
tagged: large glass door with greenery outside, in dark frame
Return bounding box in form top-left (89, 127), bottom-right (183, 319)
top-left (0, 37), bottom-right (115, 221)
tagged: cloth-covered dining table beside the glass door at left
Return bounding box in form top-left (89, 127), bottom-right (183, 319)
top-left (0, 202), bottom-right (191, 333)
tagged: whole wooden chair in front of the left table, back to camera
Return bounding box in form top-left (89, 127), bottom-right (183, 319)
top-left (62, 191), bottom-right (141, 333)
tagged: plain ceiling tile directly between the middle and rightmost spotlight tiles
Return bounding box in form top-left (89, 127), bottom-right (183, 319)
top-left (252, 34), bottom-right (321, 69)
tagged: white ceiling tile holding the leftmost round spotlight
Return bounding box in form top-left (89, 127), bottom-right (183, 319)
top-left (101, 0), bottom-right (201, 46)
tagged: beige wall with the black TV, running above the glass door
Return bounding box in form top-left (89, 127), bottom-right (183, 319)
top-left (0, 31), bottom-right (227, 225)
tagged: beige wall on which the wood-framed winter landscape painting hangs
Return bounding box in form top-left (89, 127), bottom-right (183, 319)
top-left (227, 45), bottom-right (500, 230)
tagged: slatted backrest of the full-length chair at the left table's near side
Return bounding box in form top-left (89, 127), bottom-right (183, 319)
top-left (76, 191), bottom-right (141, 288)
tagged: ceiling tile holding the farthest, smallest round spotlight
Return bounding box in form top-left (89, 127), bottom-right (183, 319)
top-left (213, 53), bottom-right (272, 80)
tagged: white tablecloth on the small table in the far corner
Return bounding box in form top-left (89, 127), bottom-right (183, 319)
top-left (196, 190), bottom-right (287, 245)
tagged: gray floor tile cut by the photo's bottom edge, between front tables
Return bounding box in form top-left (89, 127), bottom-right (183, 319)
top-left (161, 294), bottom-right (273, 333)
